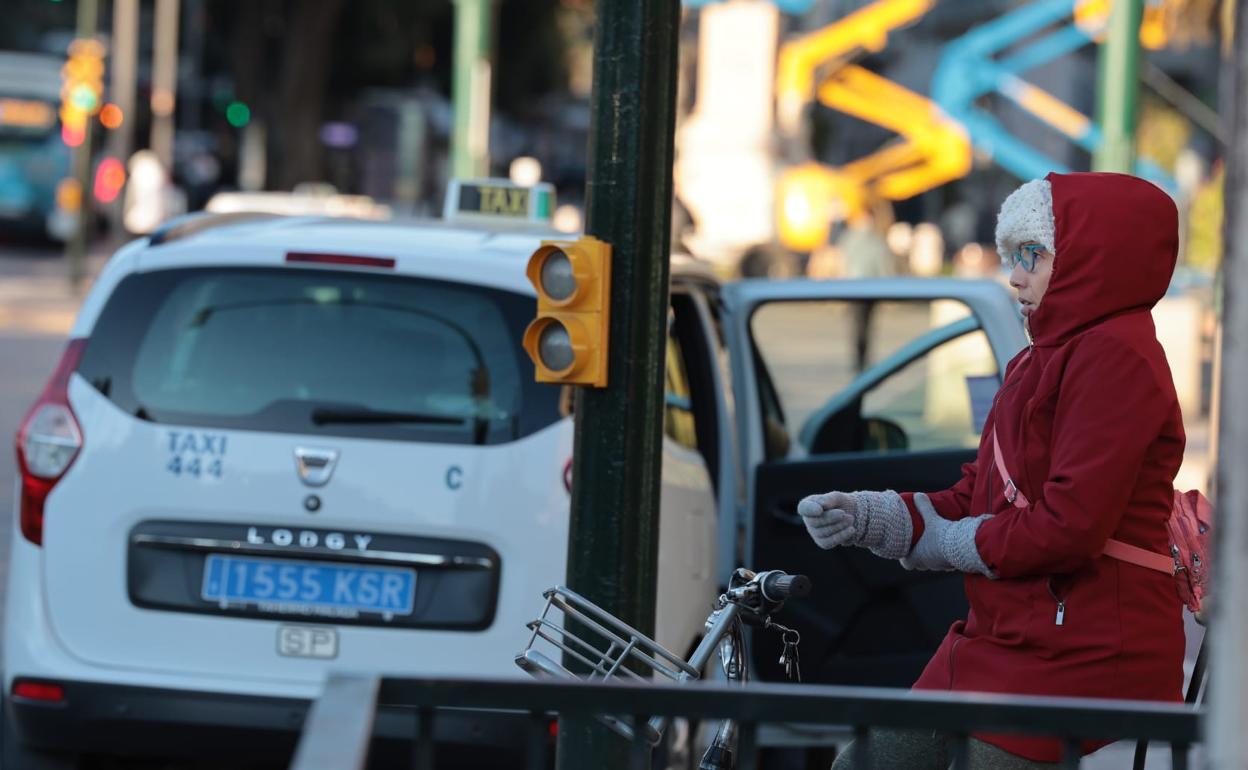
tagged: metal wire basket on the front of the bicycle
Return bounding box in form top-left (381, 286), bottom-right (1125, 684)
top-left (515, 585), bottom-right (699, 745)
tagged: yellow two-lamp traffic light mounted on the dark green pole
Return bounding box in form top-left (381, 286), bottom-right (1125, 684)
top-left (524, 236), bottom-right (612, 388)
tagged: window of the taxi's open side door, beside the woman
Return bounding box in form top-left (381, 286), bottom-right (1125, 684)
top-left (750, 300), bottom-right (1000, 459)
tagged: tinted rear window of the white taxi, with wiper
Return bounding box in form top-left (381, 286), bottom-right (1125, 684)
top-left (79, 268), bottom-right (559, 444)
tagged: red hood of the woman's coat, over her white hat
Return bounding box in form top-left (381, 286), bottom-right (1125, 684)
top-left (1028, 173), bottom-right (1178, 346)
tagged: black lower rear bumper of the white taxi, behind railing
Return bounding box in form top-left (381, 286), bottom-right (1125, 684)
top-left (5, 681), bottom-right (546, 761)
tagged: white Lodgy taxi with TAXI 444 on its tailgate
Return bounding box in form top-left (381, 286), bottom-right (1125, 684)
top-left (2, 187), bottom-right (730, 770)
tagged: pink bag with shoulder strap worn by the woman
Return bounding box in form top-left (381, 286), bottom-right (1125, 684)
top-left (992, 428), bottom-right (1213, 619)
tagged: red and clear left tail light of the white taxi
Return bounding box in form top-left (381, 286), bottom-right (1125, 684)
top-left (17, 339), bottom-right (86, 545)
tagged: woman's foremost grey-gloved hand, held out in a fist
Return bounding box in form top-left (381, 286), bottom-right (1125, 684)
top-left (797, 490), bottom-right (914, 559)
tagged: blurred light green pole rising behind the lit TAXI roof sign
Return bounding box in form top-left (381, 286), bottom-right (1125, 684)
top-left (451, 0), bottom-right (493, 178)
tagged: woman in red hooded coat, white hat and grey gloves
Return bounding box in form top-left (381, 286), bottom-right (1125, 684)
top-left (799, 173), bottom-right (1186, 770)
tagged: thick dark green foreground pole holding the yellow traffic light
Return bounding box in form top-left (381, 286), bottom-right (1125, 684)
top-left (558, 0), bottom-right (680, 770)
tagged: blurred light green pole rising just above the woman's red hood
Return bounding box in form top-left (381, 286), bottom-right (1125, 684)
top-left (1092, 0), bottom-right (1144, 173)
